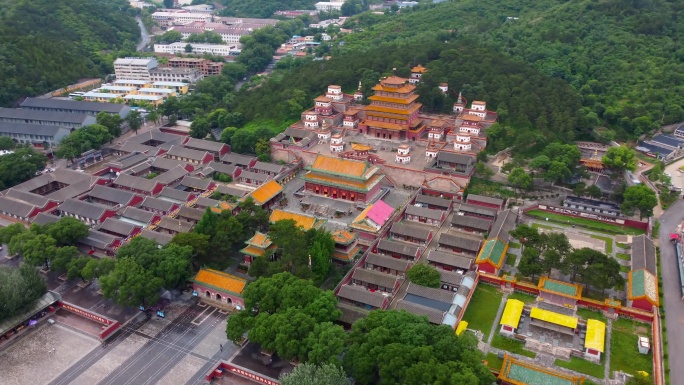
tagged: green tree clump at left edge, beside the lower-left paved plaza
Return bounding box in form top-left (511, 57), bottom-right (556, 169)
top-left (0, 264), bottom-right (47, 322)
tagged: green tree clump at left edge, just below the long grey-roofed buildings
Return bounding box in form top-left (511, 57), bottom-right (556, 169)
top-left (0, 146), bottom-right (47, 190)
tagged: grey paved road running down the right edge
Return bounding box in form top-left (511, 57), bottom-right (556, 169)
top-left (659, 199), bottom-right (684, 385)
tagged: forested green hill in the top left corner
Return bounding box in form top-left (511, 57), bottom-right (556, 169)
top-left (0, 0), bottom-right (140, 106)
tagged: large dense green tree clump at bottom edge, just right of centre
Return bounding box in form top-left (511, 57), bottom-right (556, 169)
top-left (343, 310), bottom-right (494, 385)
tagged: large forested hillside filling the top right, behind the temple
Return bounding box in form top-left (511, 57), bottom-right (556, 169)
top-left (343, 0), bottom-right (684, 137)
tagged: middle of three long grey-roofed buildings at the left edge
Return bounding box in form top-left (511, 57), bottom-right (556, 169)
top-left (0, 108), bottom-right (95, 129)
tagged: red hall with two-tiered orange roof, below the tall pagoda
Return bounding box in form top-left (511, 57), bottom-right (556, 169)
top-left (303, 155), bottom-right (385, 202)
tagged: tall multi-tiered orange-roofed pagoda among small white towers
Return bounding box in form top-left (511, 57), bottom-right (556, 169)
top-left (359, 76), bottom-right (426, 141)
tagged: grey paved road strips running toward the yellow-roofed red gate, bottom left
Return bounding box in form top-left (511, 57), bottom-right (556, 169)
top-left (50, 305), bottom-right (235, 385)
